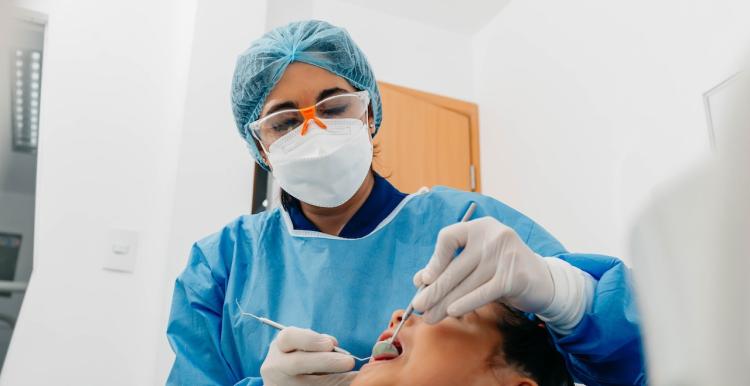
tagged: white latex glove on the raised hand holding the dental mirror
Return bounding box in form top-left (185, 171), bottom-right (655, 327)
top-left (413, 217), bottom-right (594, 333)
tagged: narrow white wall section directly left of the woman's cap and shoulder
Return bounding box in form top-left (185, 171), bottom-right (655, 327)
top-left (155, 0), bottom-right (265, 384)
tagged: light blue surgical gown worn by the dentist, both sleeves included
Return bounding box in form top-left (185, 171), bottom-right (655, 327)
top-left (167, 188), bottom-right (645, 386)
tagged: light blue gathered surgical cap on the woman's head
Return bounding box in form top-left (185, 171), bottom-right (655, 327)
top-left (232, 20), bottom-right (382, 170)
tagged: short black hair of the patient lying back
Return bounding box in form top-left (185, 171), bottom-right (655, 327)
top-left (495, 307), bottom-right (574, 386)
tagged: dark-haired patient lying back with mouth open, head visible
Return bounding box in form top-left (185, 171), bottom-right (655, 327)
top-left (351, 303), bottom-right (573, 386)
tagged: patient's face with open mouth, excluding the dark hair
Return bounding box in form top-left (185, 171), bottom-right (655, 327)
top-left (352, 303), bottom-right (532, 386)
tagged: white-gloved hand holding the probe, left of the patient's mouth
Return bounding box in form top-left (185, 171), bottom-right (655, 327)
top-left (260, 327), bottom-right (357, 386)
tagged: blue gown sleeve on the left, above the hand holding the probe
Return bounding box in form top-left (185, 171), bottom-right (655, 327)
top-left (167, 245), bottom-right (263, 386)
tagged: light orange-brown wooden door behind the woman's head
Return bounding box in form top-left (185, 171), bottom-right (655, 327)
top-left (374, 82), bottom-right (480, 193)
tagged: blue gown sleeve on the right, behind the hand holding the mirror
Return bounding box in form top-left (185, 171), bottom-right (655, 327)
top-left (527, 216), bottom-right (647, 386)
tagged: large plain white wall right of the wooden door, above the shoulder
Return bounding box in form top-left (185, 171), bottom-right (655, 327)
top-left (474, 0), bottom-right (750, 258)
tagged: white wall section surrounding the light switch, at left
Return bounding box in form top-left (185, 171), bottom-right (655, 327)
top-left (0, 0), bottom-right (200, 386)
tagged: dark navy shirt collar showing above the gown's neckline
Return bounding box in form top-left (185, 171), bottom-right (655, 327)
top-left (287, 173), bottom-right (406, 239)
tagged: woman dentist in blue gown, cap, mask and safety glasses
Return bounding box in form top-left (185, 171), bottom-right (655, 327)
top-left (167, 21), bottom-right (646, 386)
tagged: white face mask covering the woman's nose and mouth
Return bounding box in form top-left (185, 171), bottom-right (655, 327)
top-left (268, 119), bottom-right (372, 208)
